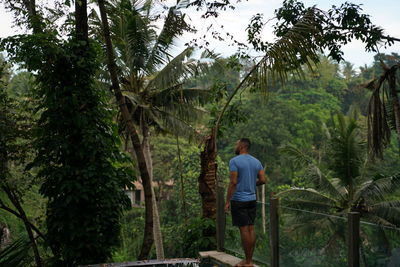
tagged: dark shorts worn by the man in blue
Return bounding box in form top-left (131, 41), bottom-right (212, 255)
top-left (231, 200), bottom-right (257, 227)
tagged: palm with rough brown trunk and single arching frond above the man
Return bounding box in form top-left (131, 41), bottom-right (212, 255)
top-left (199, 9), bottom-right (321, 222)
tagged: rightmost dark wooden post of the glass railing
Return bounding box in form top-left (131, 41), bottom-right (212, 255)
top-left (348, 212), bottom-right (360, 267)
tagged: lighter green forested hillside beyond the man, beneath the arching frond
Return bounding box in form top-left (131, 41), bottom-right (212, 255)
top-left (219, 55), bottom-right (398, 191)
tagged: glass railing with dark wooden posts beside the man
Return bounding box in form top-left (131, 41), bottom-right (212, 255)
top-left (217, 196), bottom-right (400, 267)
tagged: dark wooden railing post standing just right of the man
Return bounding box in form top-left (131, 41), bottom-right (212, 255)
top-left (269, 194), bottom-right (279, 267)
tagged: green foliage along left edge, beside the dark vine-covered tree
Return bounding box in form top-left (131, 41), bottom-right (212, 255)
top-left (0, 58), bottom-right (43, 266)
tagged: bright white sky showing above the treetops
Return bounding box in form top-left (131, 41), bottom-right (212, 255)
top-left (0, 0), bottom-right (400, 66)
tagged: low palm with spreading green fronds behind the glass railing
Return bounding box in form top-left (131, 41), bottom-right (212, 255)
top-left (277, 113), bottom-right (400, 260)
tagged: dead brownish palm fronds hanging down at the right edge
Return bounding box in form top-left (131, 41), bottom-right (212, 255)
top-left (365, 64), bottom-right (400, 159)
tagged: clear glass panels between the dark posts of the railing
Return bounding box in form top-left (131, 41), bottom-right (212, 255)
top-left (225, 202), bottom-right (400, 267)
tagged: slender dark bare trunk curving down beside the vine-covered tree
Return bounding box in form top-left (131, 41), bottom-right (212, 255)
top-left (98, 0), bottom-right (153, 260)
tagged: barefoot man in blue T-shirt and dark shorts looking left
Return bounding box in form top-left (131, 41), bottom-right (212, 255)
top-left (225, 138), bottom-right (265, 267)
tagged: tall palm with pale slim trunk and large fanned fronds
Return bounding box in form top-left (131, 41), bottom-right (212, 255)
top-left (92, 0), bottom-right (212, 259)
